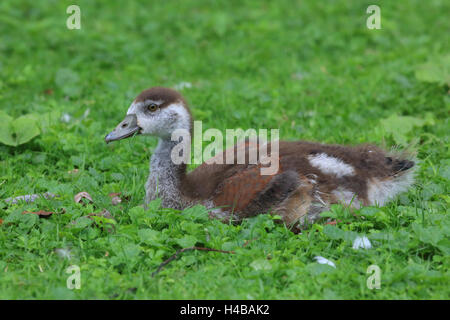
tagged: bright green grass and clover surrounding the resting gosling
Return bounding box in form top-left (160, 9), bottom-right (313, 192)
top-left (0, 0), bottom-right (450, 299)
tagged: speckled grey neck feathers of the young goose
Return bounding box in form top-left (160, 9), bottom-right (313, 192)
top-left (145, 138), bottom-right (186, 209)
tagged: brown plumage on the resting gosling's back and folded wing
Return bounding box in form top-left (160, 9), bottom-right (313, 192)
top-left (186, 141), bottom-right (414, 222)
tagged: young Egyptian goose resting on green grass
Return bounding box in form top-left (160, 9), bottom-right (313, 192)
top-left (105, 87), bottom-right (414, 227)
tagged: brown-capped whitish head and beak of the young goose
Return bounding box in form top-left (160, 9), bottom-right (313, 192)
top-left (105, 87), bottom-right (192, 143)
